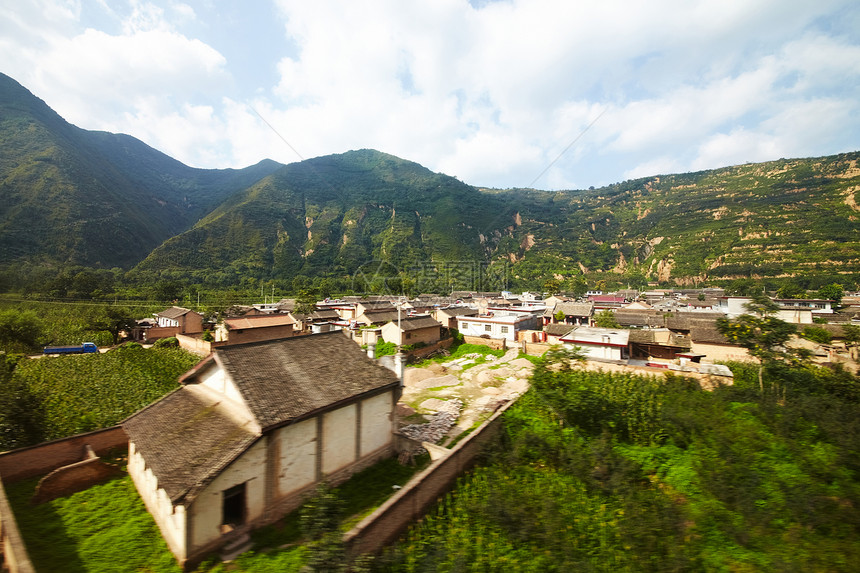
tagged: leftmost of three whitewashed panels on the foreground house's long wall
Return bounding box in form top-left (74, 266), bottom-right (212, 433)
top-left (274, 418), bottom-right (317, 497)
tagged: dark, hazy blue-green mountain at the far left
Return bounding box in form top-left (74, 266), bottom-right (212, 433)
top-left (0, 74), bottom-right (281, 268)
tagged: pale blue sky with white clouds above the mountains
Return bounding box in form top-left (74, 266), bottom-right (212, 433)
top-left (0, 0), bottom-right (860, 189)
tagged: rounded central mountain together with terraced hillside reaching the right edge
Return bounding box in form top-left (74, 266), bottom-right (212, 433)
top-left (138, 150), bottom-right (860, 290)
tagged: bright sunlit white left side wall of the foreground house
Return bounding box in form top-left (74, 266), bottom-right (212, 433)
top-left (128, 442), bottom-right (188, 560)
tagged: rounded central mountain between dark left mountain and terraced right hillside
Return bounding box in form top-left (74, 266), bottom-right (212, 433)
top-left (131, 150), bottom-right (511, 281)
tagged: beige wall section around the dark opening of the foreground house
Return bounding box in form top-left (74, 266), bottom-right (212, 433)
top-left (188, 437), bottom-right (267, 550)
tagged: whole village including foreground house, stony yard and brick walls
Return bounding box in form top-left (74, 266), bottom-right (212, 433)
top-left (0, 289), bottom-right (860, 571)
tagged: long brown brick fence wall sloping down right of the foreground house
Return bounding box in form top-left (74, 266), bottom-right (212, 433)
top-left (344, 401), bottom-right (514, 555)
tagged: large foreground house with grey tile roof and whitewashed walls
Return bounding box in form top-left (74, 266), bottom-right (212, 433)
top-left (123, 332), bottom-right (400, 568)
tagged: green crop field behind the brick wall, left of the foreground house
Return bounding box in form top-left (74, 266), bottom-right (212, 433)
top-left (0, 344), bottom-right (200, 451)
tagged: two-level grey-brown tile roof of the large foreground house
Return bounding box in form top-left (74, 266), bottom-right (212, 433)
top-left (122, 332), bottom-right (399, 502)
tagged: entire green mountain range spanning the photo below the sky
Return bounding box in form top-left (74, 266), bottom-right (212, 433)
top-left (0, 72), bottom-right (860, 291)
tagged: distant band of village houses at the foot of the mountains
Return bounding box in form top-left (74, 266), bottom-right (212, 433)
top-left (138, 288), bottom-right (860, 373)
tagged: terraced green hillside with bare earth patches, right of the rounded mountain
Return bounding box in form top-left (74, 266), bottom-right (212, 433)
top-left (498, 153), bottom-right (860, 283)
